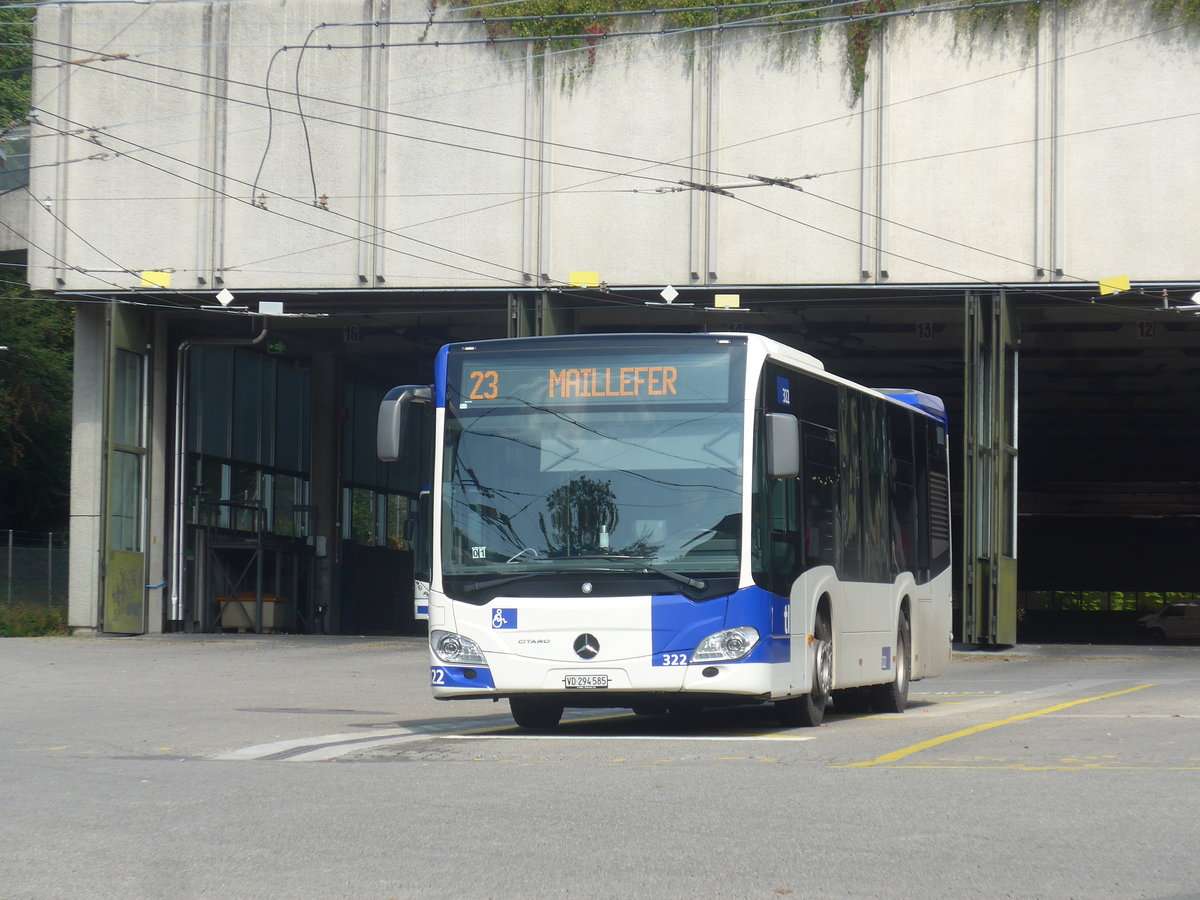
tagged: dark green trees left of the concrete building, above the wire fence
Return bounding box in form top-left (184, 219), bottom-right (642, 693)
top-left (0, 269), bottom-right (74, 532)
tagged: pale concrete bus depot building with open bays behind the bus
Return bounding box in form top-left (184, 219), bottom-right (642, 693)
top-left (16, 0), bottom-right (1200, 643)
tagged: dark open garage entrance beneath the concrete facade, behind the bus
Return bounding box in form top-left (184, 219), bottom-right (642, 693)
top-left (129, 287), bottom-right (1200, 644)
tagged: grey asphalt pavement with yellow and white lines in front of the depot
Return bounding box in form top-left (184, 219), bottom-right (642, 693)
top-left (0, 636), bottom-right (1200, 900)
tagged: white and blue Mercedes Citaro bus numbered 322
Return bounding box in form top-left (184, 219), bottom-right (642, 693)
top-left (378, 334), bottom-right (952, 728)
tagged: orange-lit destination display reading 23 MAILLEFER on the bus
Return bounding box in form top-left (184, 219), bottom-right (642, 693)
top-left (449, 347), bottom-right (731, 409)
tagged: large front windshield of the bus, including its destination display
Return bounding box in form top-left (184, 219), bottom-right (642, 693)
top-left (442, 344), bottom-right (744, 582)
